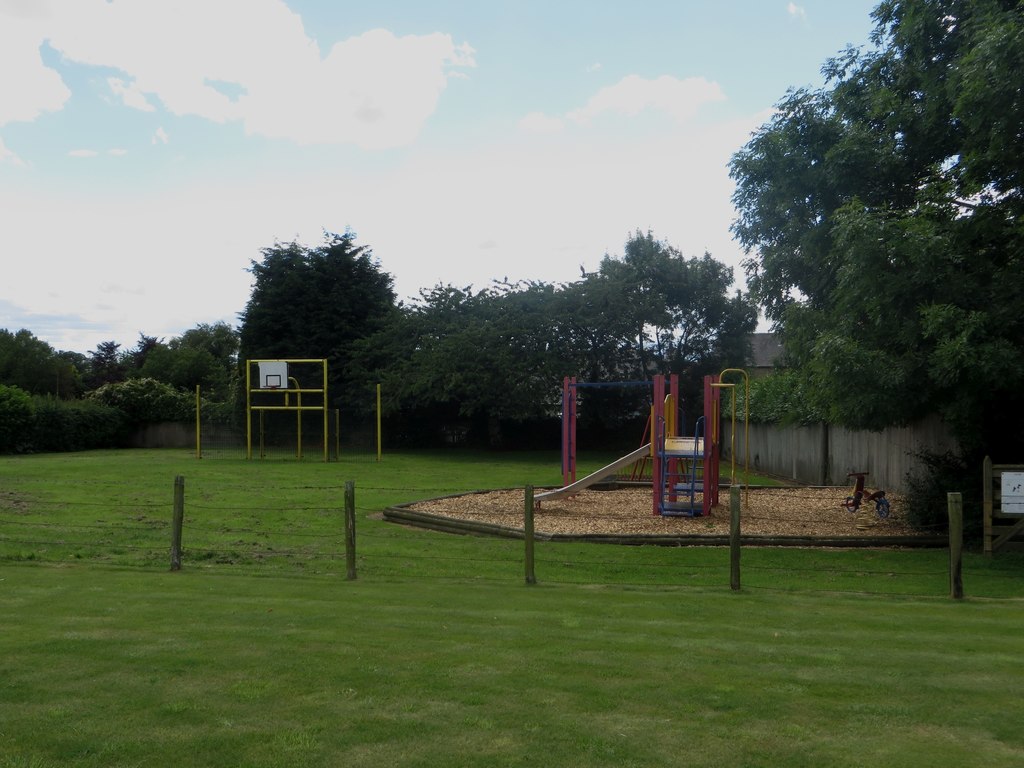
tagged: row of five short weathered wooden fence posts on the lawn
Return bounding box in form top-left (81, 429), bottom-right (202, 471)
top-left (171, 475), bottom-right (964, 600)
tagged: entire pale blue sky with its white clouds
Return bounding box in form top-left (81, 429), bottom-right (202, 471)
top-left (0, 0), bottom-right (877, 352)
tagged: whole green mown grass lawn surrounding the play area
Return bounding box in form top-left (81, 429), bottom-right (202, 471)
top-left (0, 451), bottom-right (1024, 768)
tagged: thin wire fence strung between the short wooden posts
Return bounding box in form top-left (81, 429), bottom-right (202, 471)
top-left (0, 481), bottom-right (1024, 597)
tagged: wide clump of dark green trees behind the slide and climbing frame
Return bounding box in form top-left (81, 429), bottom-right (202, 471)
top-left (354, 232), bottom-right (756, 444)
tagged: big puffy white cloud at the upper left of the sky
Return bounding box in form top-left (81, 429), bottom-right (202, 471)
top-left (8, 0), bottom-right (475, 147)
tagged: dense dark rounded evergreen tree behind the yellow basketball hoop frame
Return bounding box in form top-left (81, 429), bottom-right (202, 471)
top-left (240, 232), bottom-right (395, 413)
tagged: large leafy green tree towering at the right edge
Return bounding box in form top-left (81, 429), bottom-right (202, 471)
top-left (731, 0), bottom-right (1024, 460)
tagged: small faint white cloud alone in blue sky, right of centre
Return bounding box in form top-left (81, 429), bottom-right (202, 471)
top-left (566, 75), bottom-right (725, 124)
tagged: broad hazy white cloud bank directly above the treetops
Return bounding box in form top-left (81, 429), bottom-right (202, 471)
top-left (0, 100), bottom-right (767, 351)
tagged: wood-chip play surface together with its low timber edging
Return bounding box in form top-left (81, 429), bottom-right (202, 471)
top-left (385, 486), bottom-right (938, 546)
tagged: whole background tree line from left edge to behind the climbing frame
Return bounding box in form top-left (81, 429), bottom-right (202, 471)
top-left (0, 231), bottom-right (757, 454)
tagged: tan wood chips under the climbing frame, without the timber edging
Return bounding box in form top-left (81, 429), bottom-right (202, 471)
top-left (409, 487), bottom-right (914, 537)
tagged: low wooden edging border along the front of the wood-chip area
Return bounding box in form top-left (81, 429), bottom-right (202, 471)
top-left (384, 490), bottom-right (949, 549)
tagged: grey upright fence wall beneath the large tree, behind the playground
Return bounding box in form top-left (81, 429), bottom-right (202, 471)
top-left (723, 417), bottom-right (956, 492)
